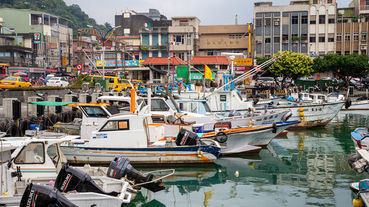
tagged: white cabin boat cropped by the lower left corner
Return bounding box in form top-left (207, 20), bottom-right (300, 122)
top-left (0, 133), bottom-right (154, 206)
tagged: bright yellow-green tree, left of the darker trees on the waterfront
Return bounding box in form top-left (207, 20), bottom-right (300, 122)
top-left (269, 51), bottom-right (314, 88)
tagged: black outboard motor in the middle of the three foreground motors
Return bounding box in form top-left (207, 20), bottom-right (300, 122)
top-left (54, 164), bottom-right (119, 196)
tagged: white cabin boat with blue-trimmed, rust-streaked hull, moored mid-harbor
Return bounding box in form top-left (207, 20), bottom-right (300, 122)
top-left (62, 106), bottom-right (220, 165)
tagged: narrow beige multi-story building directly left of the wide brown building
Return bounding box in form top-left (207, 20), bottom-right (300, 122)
top-left (169, 17), bottom-right (200, 61)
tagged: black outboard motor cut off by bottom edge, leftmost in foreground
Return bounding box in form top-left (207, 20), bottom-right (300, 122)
top-left (19, 183), bottom-right (77, 207)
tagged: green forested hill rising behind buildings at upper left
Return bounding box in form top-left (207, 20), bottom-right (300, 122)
top-left (0, 0), bottom-right (111, 34)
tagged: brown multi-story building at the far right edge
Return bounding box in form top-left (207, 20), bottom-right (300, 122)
top-left (336, 8), bottom-right (369, 55)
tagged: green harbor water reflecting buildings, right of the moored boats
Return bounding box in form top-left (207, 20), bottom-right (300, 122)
top-left (131, 111), bottom-right (369, 207)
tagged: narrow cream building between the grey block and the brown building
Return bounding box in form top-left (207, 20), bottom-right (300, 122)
top-left (309, 0), bottom-right (337, 57)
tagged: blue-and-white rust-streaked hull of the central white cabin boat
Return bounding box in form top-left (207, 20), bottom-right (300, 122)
top-left (62, 146), bottom-right (220, 165)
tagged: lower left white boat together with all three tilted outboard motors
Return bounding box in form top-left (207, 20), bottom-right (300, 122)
top-left (0, 132), bottom-right (174, 206)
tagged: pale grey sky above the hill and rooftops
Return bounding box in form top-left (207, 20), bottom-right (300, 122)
top-left (64, 0), bottom-right (351, 25)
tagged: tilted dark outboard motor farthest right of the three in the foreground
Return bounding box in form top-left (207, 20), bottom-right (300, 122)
top-left (107, 157), bottom-right (165, 192)
